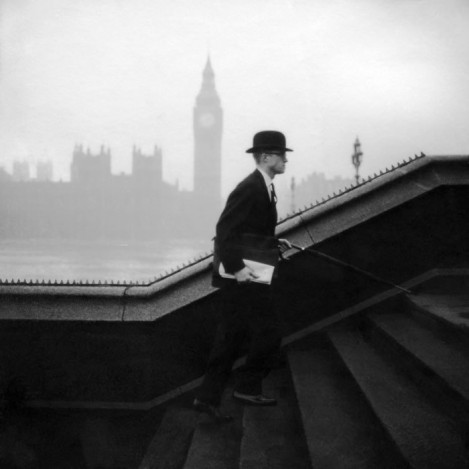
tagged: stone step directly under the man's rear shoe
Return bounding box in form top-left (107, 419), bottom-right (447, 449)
top-left (183, 387), bottom-right (243, 469)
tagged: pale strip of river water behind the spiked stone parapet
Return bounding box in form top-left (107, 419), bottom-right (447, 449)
top-left (0, 239), bottom-right (212, 282)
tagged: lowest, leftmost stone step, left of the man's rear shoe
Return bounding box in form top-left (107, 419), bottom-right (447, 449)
top-left (139, 407), bottom-right (198, 469)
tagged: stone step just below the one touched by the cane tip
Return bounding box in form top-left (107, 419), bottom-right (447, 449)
top-left (368, 308), bottom-right (469, 405)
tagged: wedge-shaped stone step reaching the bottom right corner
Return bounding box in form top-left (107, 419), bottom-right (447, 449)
top-left (329, 328), bottom-right (468, 469)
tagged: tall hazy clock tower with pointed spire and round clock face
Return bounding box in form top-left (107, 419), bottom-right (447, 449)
top-left (194, 58), bottom-right (223, 218)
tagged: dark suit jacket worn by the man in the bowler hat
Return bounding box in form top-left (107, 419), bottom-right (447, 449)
top-left (212, 169), bottom-right (277, 286)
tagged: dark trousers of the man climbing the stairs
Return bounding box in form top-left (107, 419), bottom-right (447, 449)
top-left (198, 282), bottom-right (281, 406)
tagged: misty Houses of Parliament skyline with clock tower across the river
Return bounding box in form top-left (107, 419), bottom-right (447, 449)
top-left (0, 59), bottom-right (350, 241)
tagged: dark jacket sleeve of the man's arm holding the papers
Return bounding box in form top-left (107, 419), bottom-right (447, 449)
top-left (216, 185), bottom-right (253, 273)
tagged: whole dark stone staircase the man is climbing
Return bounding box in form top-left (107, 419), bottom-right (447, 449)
top-left (139, 294), bottom-right (469, 469)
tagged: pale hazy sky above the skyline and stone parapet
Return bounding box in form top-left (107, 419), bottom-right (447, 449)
top-left (0, 0), bottom-right (469, 196)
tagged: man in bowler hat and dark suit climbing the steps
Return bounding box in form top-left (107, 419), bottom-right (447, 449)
top-left (194, 131), bottom-right (292, 422)
